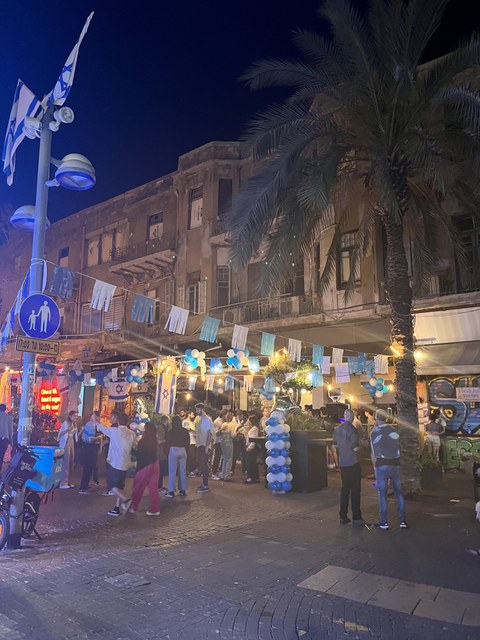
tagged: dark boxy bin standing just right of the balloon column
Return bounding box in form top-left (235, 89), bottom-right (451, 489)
top-left (290, 431), bottom-right (328, 493)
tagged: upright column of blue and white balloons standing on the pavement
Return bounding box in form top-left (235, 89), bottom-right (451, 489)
top-left (265, 411), bottom-right (293, 493)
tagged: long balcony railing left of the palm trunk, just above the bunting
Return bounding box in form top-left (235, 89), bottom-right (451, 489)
top-left (210, 294), bottom-right (322, 324)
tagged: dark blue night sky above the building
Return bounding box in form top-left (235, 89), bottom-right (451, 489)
top-left (0, 0), bottom-right (480, 221)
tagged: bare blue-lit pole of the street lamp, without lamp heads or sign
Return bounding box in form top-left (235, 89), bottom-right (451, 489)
top-left (8, 107), bottom-right (53, 549)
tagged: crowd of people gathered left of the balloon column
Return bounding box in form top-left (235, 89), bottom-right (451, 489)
top-left (54, 403), bottom-right (269, 517)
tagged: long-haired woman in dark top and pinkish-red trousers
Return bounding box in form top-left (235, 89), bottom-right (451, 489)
top-left (130, 422), bottom-right (160, 516)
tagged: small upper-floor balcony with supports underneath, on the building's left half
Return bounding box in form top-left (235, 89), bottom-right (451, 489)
top-left (110, 233), bottom-right (178, 282)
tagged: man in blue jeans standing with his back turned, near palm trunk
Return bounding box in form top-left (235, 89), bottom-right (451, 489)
top-left (370, 411), bottom-right (408, 530)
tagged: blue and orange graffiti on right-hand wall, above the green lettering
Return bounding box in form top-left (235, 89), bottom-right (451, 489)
top-left (427, 376), bottom-right (480, 436)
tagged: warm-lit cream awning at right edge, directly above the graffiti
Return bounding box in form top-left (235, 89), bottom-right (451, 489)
top-left (416, 340), bottom-right (480, 376)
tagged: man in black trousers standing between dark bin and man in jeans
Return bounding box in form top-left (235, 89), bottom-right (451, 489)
top-left (333, 409), bottom-right (363, 524)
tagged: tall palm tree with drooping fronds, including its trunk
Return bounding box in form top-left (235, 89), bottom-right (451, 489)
top-left (227, 0), bottom-right (480, 493)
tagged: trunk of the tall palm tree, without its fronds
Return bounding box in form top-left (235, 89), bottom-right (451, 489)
top-left (382, 212), bottom-right (420, 494)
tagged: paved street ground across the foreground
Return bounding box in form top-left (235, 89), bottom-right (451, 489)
top-left (0, 464), bottom-right (480, 640)
